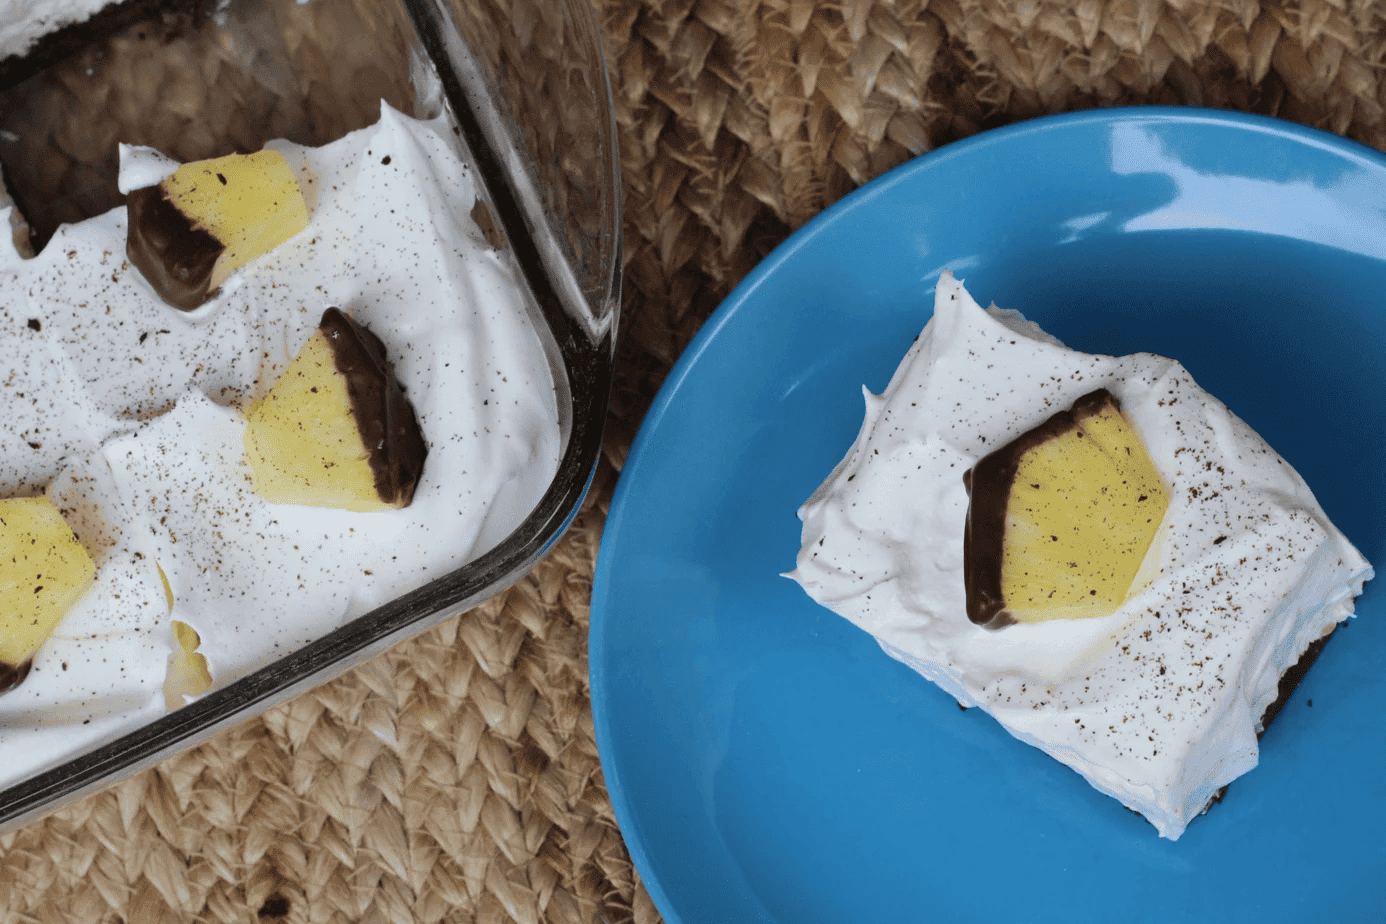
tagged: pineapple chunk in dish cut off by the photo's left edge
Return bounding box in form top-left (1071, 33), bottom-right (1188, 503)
top-left (0, 497), bottom-right (96, 693)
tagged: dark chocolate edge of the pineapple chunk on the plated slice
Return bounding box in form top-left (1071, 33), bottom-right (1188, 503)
top-left (962, 388), bottom-right (1121, 629)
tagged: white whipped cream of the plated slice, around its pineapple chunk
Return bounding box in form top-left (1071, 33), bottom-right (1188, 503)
top-left (790, 273), bottom-right (1372, 839)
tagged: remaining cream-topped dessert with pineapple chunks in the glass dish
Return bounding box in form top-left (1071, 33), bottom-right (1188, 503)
top-left (0, 6), bottom-right (561, 788)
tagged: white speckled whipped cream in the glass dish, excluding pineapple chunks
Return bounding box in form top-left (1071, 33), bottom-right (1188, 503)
top-left (0, 104), bottom-right (561, 785)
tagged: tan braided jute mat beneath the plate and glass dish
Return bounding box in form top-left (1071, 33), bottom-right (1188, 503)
top-left (0, 0), bottom-right (1386, 924)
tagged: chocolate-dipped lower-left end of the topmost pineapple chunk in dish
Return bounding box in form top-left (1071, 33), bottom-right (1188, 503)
top-left (125, 186), bottom-right (226, 312)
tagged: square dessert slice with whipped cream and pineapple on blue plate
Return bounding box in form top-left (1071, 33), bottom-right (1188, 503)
top-left (791, 273), bottom-right (1372, 839)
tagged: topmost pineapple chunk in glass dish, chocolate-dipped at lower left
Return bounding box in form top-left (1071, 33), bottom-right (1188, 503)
top-left (125, 151), bottom-right (308, 312)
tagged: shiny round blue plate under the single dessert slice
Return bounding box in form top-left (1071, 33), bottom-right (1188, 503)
top-left (590, 109), bottom-right (1386, 924)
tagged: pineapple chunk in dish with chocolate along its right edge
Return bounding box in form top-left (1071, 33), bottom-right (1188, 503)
top-left (245, 308), bottom-right (428, 511)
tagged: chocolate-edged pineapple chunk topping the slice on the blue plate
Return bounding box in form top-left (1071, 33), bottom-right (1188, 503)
top-left (963, 388), bottom-right (1170, 628)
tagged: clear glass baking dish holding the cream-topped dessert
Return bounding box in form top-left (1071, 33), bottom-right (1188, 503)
top-left (0, 0), bottom-right (621, 830)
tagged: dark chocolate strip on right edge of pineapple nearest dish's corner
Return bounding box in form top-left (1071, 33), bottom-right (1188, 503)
top-left (319, 308), bottom-right (428, 507)
